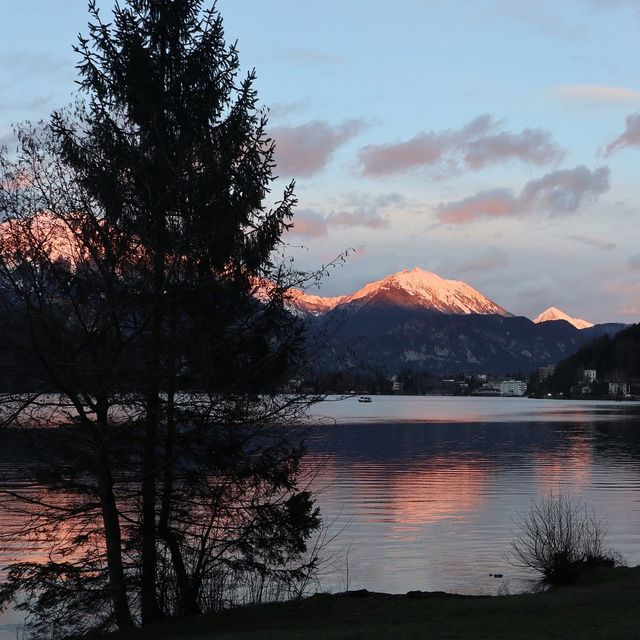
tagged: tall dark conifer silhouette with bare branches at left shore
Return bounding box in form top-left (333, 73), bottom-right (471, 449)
top-left (0, 0), bottom-right (320, 631)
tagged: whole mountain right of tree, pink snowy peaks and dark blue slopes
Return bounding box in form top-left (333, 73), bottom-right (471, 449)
top-left (292, 269), bottom-right (624, 375)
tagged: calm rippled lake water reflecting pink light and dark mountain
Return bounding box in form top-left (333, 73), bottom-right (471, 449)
top-left (0, 396), bottom-right (640, 640)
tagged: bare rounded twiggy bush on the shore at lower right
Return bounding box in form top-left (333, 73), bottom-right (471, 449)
top-left (510, 495), bottom-right (620, 584)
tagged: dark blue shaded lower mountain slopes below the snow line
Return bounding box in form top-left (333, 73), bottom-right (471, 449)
top-left (310, 304), bottom-right (622, 375)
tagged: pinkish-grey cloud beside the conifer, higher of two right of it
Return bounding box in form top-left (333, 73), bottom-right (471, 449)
top-left (270, 120), bottom-right (364, 177)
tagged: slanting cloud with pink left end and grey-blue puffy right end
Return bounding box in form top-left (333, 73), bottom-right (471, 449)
top-left (436, 165), bottom-right (610, 224)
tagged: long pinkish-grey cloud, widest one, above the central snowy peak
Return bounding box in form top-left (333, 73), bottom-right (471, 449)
top-left (359, 114), bottom-right (565, 177)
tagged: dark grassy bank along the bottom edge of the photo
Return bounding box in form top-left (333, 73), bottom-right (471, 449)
top-left (95, 566), bottom-right (640, 640)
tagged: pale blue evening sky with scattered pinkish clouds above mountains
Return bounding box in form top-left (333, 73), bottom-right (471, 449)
top-left (0, 0), bottom-right (640, 322)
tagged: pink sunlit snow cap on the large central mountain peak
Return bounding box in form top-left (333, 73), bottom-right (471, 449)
top-left (292, 268), bottom-right (511, 316)
